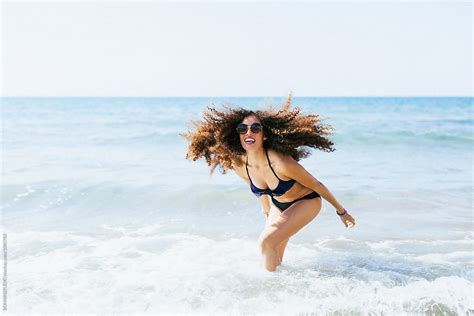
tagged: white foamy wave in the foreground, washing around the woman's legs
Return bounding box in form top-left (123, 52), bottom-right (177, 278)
top-left (8, 225), bottom-right (474, 314)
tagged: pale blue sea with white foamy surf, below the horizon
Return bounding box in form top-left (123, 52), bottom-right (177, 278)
top-left (1, 97), bottom-right (474, 315)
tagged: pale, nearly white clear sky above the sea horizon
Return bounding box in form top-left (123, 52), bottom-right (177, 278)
top-left (0, 1), bottom-right (473, 97)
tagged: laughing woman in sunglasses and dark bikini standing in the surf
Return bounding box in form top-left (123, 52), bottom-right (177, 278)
top-left (180, 94), bottom-right (355, 271)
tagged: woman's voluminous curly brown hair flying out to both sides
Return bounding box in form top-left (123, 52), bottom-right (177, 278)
top-left (179, 94), bottom-right (335, 174)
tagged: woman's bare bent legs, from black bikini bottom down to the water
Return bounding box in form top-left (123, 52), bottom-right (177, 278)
top-left (259, 198), bottom-right (321, 271)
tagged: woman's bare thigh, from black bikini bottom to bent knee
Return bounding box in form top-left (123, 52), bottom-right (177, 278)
top-left (260, 198), bottom-right (321, 246)
